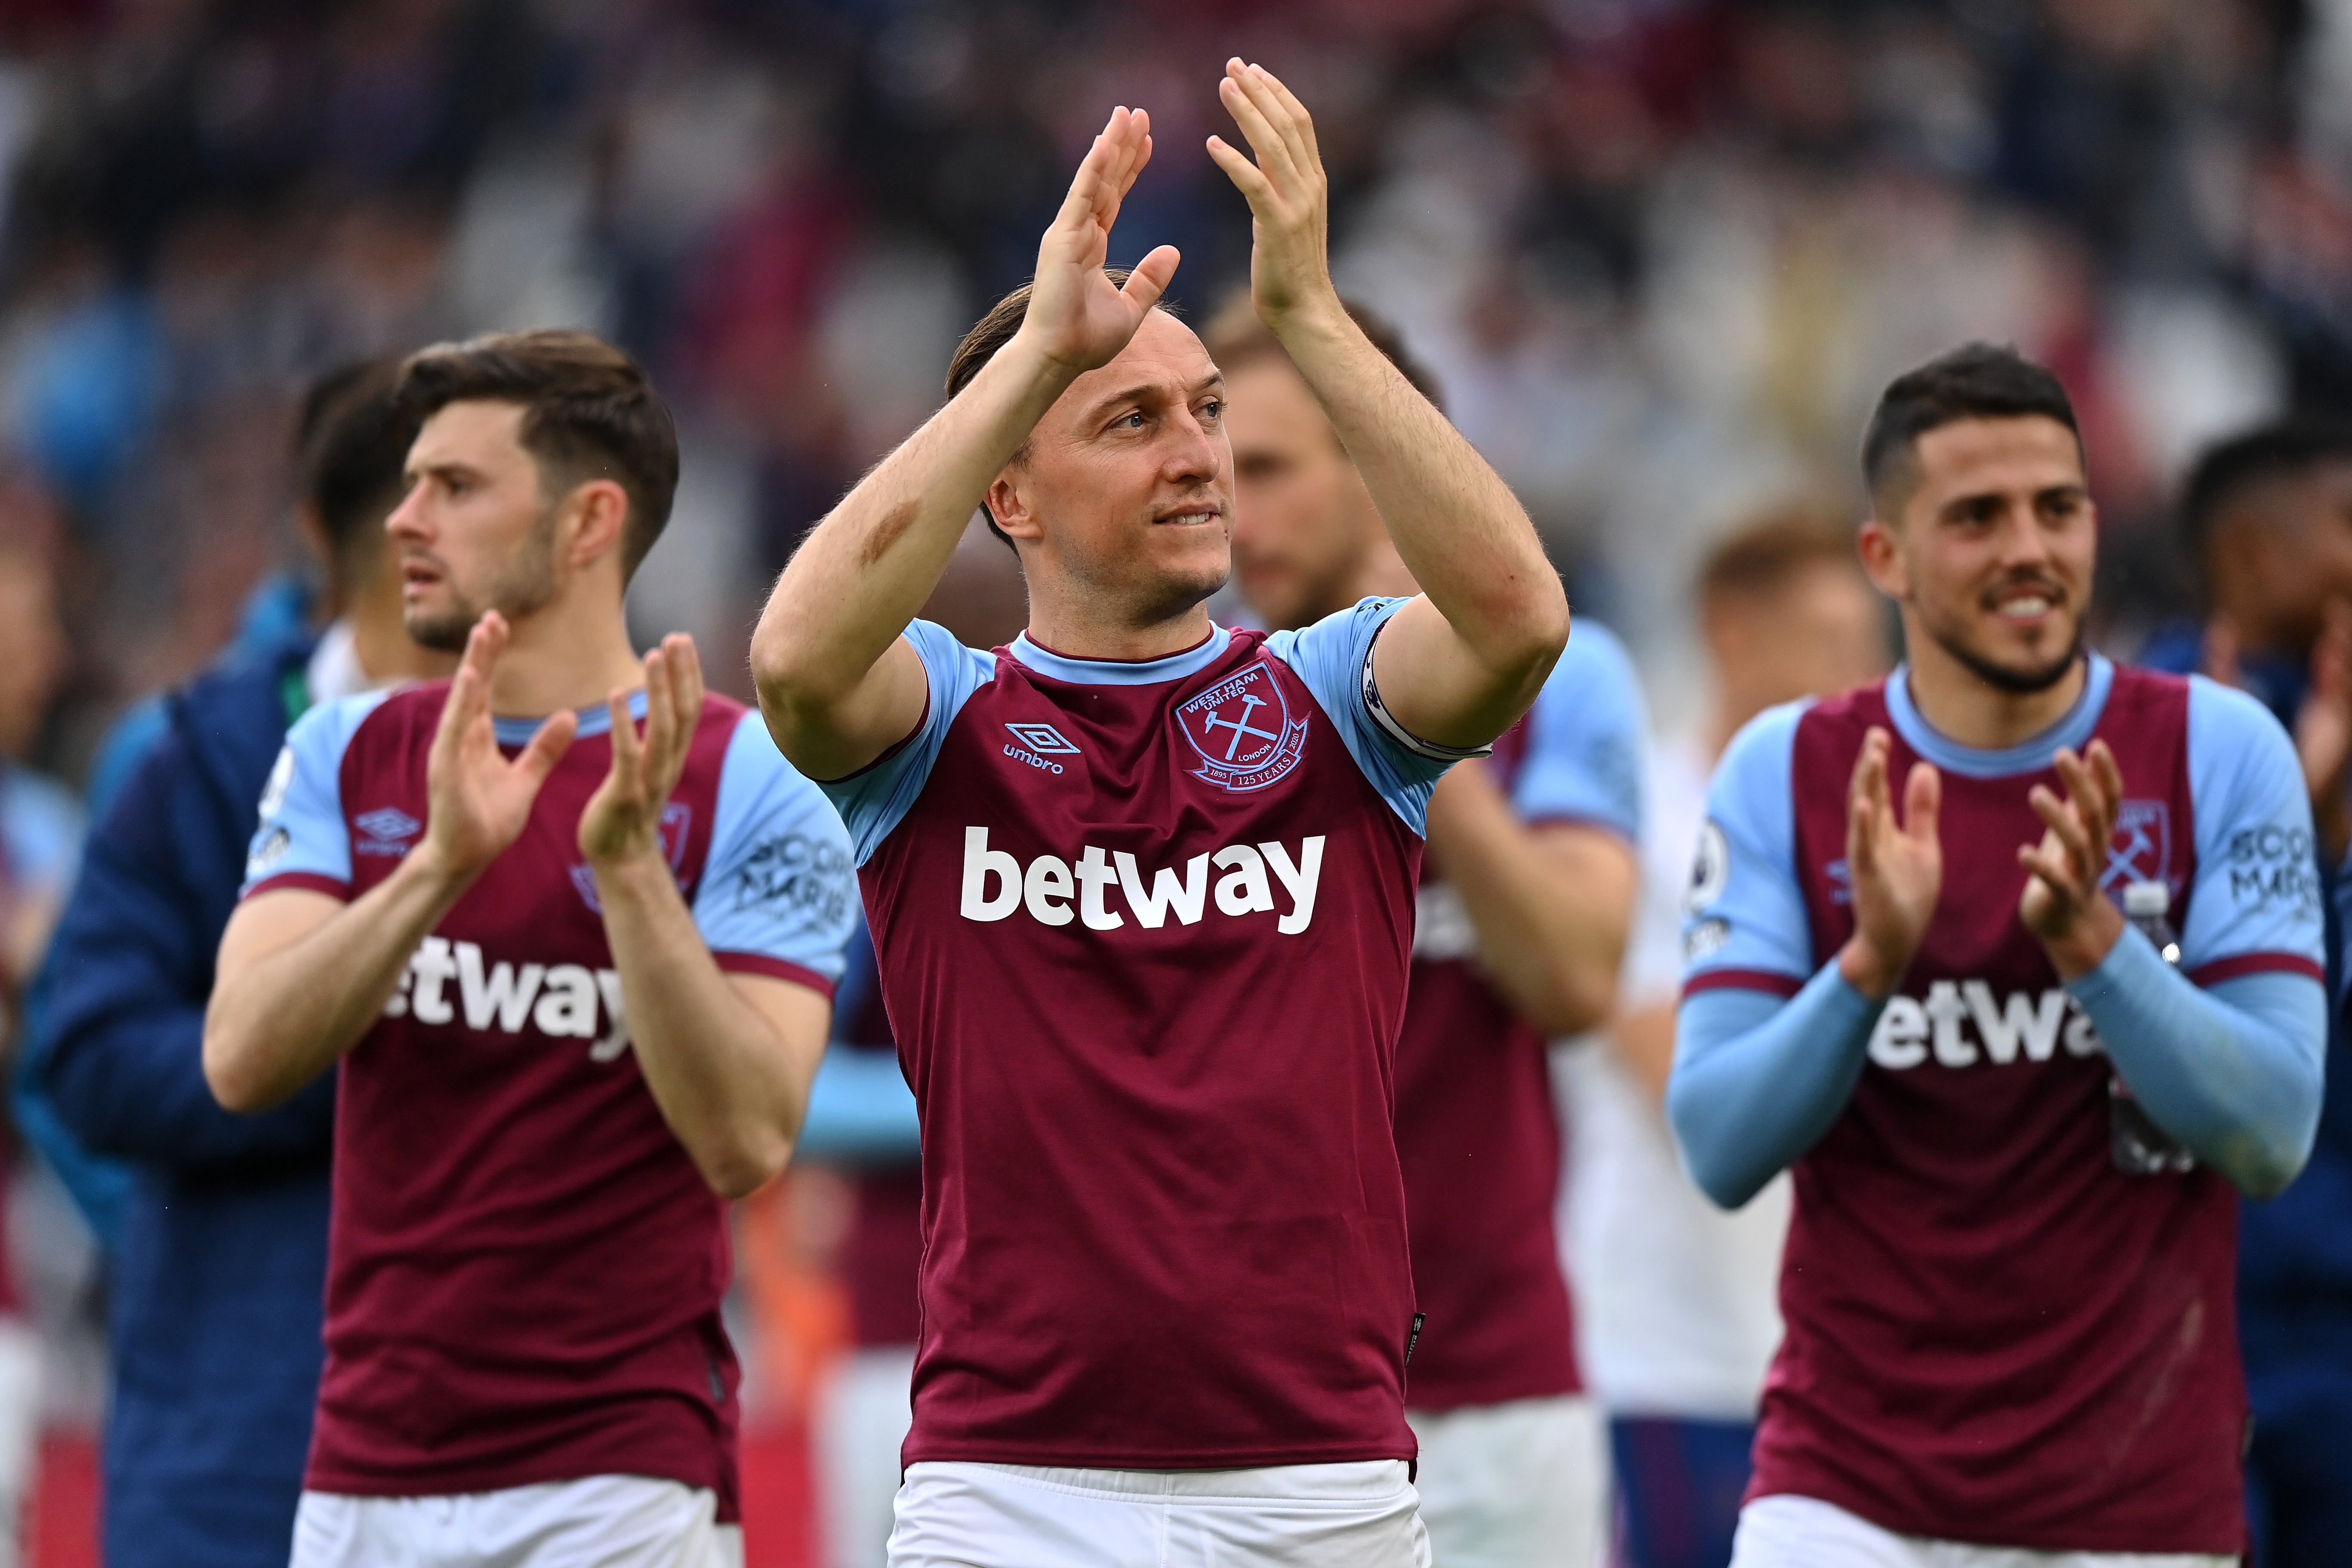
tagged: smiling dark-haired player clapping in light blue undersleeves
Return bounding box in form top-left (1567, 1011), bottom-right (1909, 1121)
top-left (1668, 346), bottom-right (2326, 1568)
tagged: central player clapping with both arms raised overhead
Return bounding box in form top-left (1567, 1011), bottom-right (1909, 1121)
top-left (753, 61), bottom-right (1566, 1568)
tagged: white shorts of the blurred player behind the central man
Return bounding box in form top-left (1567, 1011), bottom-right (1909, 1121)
top-left (1406, 1394), bottom-right (1609, 1568)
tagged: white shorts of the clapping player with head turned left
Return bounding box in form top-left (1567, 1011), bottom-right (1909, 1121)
top-left (292, 1476), bottom-right (743, 1568)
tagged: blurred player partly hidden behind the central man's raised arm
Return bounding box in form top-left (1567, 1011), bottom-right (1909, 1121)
top-left (1207, 296), bottom-right (1644, 1568)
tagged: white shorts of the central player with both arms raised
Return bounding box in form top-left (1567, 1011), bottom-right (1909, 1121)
top-left (889, 1460), bottom-right (1430, 1568)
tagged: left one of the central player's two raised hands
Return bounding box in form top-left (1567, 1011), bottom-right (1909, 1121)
top-left (1021, 108), bottom-right (1176, 374)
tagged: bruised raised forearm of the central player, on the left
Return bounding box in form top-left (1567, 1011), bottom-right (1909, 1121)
top-left (750, 336), bottom-right (1075, 729)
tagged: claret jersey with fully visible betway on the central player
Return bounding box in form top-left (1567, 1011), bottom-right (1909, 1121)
top-left (826, 600), bottom-right (1456, 1469)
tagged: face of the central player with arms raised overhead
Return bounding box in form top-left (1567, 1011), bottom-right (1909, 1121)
top-left (988, 310), bottom-right (1232, 625)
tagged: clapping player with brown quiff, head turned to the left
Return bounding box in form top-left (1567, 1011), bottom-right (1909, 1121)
top-left (205, 331), bottom-right (851, 1568)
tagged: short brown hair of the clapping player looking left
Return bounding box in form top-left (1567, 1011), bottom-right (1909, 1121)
top-left (400, 329), bottom-right (677, 578)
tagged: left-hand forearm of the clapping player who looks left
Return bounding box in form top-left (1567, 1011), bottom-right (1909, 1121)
top-left (205, 860), bottom-right (473, 1114)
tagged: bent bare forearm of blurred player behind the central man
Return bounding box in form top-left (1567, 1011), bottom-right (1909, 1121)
top-left (1430, 764), bottom-right (1635, 1034)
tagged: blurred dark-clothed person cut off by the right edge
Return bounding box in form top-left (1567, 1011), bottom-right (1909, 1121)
top-left (2143, 419), bottom-right (2352, 1568)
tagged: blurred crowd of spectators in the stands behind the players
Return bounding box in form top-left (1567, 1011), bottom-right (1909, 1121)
top-left (0, 0), bottom-right (2352, 1561)
